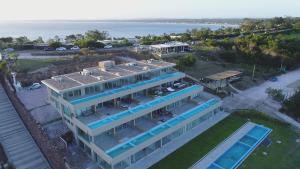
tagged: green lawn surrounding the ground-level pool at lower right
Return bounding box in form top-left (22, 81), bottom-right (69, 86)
top-left (151, 111), bottom-right (300, 169)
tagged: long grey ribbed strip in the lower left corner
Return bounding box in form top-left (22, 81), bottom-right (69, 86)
top-left (0, 85), bottom-right (50, 169)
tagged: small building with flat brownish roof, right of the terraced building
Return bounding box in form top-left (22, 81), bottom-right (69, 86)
top-left (204, 70), bottom-right (242, 92)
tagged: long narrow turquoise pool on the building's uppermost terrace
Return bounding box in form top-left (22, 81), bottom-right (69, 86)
top-left (70, 72), bottom-right (185, 105)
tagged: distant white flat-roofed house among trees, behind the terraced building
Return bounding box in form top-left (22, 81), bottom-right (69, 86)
top-left (150, 41), bottom-right (190, 58)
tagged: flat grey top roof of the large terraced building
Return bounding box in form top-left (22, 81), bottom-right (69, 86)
top-left (42, 60), bottom-right (175, 92)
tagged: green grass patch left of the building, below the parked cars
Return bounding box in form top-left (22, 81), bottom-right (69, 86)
top-left (15, 59), bottom-right (66, 73)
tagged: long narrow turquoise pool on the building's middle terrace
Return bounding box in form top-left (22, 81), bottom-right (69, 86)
top-left (88, 85), bottom-right (203, 129)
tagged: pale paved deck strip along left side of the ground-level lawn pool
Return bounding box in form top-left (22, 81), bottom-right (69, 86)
top-left (189, 122), bottom-right (268, 169)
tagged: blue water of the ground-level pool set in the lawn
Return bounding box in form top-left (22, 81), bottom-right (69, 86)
top-left (208, 125), bottom-right (272, 169)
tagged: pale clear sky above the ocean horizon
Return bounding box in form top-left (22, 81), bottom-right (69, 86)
top-left (0, 0), bottom-right (300, 21)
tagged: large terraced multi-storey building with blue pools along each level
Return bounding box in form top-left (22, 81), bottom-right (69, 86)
top-left (42, 60), bottom-right (225, 169)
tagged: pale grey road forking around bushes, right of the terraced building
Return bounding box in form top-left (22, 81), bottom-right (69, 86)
top-left (223, 69), bottom-right (300, 129)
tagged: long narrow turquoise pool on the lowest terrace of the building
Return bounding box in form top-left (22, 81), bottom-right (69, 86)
top-left (106, 99), bottom-right (220, 158)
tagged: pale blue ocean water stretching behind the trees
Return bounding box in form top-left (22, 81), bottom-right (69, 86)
top-left (0, 21), bottom-right (236, 40)
